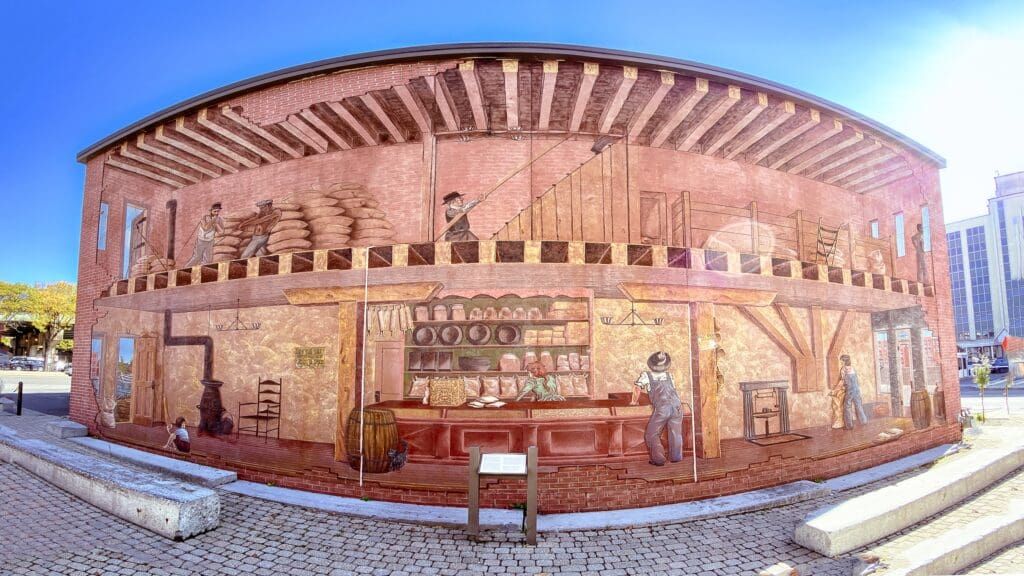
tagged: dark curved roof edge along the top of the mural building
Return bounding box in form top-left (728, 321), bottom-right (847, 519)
top-left (77, 42), bottom-right (946, 168)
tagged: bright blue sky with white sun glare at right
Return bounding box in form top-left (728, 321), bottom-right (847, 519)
top-left (0, 0), bottom-right (1024, 282)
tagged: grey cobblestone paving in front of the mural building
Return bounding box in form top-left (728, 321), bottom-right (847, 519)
top-left (0, 405), bottom-right (1014, 576)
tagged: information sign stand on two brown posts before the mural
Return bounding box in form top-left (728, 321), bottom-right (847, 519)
top-left (468, 446), bottom-right (537, 546)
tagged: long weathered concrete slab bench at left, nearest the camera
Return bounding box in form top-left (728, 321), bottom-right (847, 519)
top-left (0, 426), bottom-right (220, 540)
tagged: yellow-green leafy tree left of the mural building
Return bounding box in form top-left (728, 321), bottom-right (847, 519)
top-left (0, 282), bottom-right (76, 363)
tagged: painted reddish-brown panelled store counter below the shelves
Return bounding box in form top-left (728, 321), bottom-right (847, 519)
top-left (367, 395), bottom-right (692, 465)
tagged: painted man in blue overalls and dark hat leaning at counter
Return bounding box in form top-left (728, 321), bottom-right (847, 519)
top-left (630, 352), bottom-right (683, 466)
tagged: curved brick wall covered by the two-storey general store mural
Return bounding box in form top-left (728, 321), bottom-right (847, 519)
top-left (72, 44), bottom-right (959, 511)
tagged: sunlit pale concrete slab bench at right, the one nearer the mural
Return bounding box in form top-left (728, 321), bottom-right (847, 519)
top-left (793, 438), bottom-right (1024, 558)
